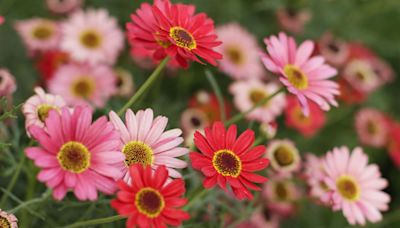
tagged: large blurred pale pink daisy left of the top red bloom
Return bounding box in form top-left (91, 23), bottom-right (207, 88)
top-left (61, 9), bottom-right (124, 64)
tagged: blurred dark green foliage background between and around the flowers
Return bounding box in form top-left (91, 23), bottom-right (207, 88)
top-left (0, 0), bottom-right (400, 227)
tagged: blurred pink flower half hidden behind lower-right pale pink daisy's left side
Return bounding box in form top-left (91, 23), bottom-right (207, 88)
top-left (304, 154), bottom-right (329, 204)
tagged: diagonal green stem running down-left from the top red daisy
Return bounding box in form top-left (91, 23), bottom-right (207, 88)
top-left (118, 57), bottom-right (169, 116)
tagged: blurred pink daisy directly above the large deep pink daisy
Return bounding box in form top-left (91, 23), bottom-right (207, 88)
top-left (48, 64), bottom-right (117, 108)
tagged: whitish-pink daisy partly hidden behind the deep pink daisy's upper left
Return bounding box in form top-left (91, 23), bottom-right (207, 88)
top-left (22, 87), bottom-right (66, 135)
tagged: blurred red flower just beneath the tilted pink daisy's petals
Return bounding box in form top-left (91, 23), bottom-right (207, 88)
top-left (285, 96), bottom-right (325, 137)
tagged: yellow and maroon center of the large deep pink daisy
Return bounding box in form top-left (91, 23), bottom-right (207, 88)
top-left (57, 141), bottom-right (90, 173)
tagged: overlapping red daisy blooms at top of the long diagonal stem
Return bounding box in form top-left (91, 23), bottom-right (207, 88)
top-left (127, 0), bottom-right (222, 68)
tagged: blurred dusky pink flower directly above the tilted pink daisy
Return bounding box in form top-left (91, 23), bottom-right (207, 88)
top-left (276, 8), bottom-right (311, 34)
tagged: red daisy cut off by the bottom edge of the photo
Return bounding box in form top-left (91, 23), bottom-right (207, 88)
top-left (111, 164), bottom-right (189, 228)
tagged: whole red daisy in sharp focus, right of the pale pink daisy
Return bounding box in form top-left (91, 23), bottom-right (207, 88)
top-left (190, 122), bottom-right (269, 200)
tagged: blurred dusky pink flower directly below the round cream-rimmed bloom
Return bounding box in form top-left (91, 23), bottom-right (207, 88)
top-left (263, 177), bottom-right (300, 217)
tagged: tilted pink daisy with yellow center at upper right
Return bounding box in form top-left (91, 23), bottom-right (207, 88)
top-left (262, 33), bottom-right (339, 116)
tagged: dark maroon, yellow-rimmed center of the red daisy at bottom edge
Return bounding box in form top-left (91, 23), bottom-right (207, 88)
top-left (135, 187), bottom-right (165, 218)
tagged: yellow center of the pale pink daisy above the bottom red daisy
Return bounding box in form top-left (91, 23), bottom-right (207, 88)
top-left (122, 141), bottom-right (154, 166)
